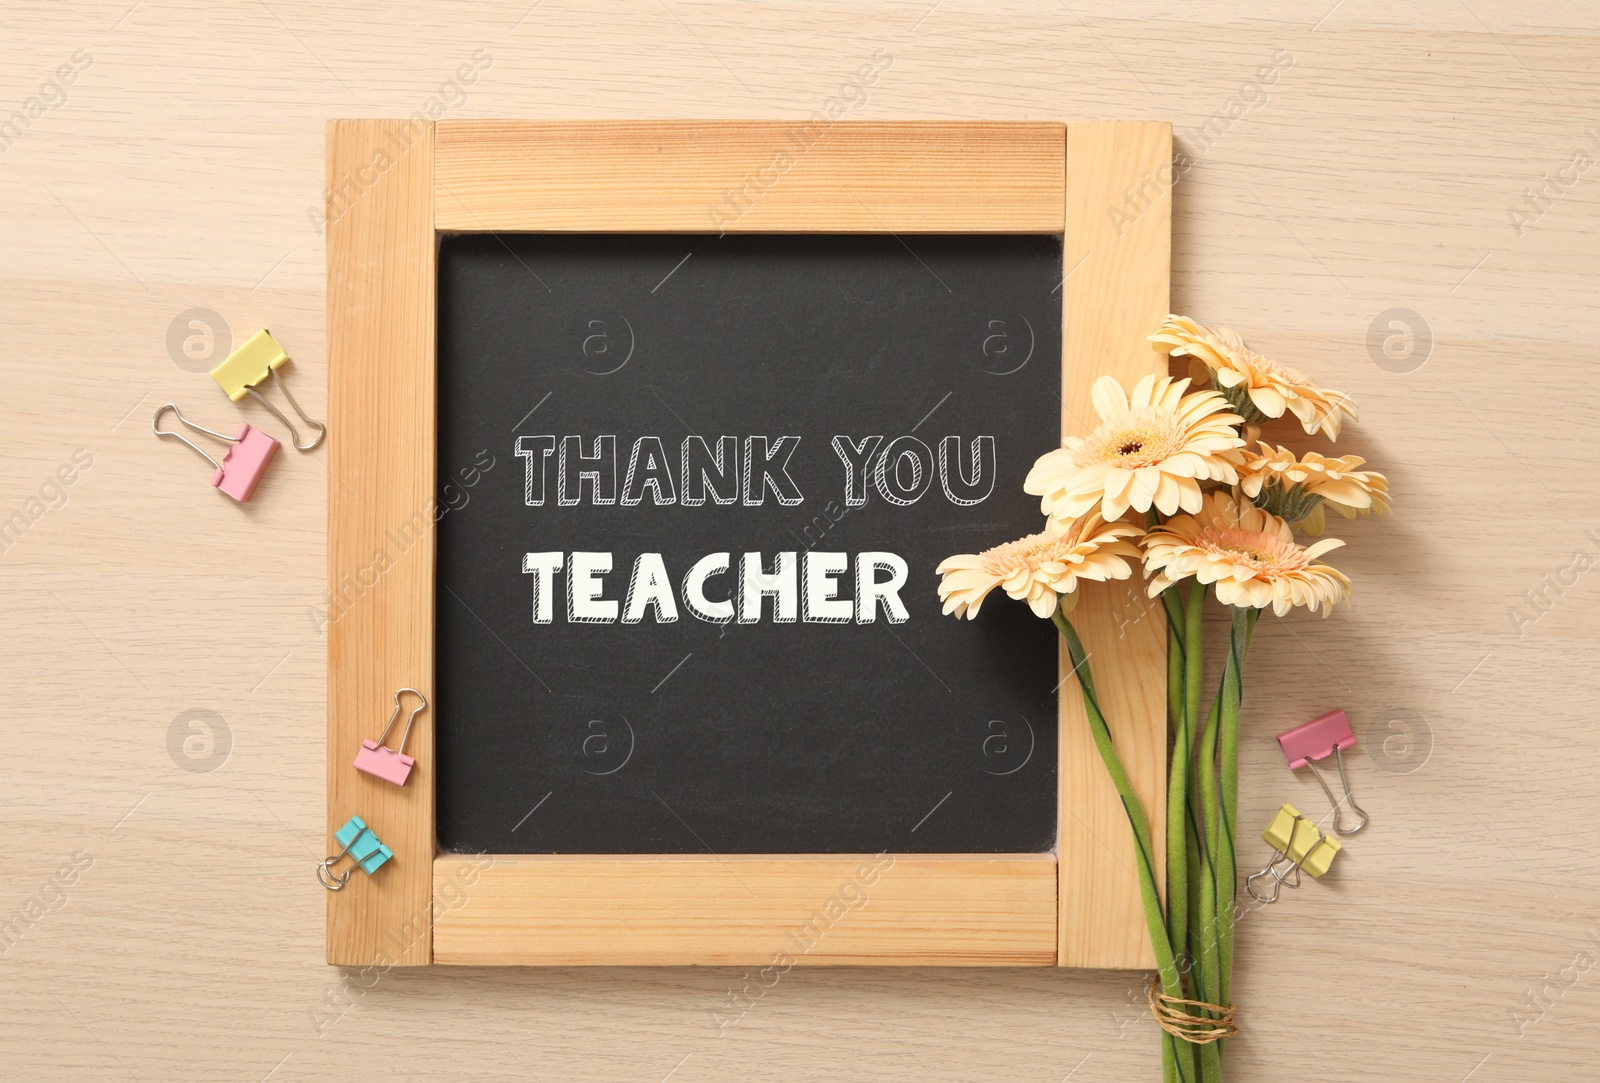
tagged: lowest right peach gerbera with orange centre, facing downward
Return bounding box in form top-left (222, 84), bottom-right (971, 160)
top-left (1141, 491), bottom-right (1350, 616)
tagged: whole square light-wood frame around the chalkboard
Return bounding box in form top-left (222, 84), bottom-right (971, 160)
top-left (326, 120), bottom-right (1173, 969)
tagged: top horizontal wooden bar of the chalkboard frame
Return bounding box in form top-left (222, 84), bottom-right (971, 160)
top-left (435, 118), bottom-right (1062, 234)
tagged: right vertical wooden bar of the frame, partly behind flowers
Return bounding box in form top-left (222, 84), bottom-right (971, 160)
top-left (1056, 120), bottom-right (1173, 968)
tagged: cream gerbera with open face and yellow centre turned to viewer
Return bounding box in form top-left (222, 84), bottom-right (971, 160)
top-left (1022, 376), bottom-right (1245, 522)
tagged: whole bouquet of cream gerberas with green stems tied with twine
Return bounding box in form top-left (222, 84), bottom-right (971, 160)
top-left (938, 315), bottom-right (1389, 1083)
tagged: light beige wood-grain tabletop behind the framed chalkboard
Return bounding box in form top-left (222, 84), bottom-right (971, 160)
top-left (0, 0), bottom-right (1600, 1083)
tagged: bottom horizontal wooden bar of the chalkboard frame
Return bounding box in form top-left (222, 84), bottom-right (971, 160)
top-left (434, 854), bottom-right (1056, 971)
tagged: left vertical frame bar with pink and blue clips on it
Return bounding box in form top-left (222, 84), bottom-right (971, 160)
top-left (328, 120), bottom-right (437, 966)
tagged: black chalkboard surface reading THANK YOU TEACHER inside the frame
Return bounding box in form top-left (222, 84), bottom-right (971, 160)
top-left (435, 235), bottom-right (1061, 854)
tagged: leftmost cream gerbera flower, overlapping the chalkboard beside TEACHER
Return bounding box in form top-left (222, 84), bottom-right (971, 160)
top-left (938, 515), bottom-right (1139, 619)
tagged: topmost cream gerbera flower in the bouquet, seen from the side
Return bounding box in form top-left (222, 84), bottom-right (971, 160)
top-left (1150, 315), bottom-right (1355, 440)
